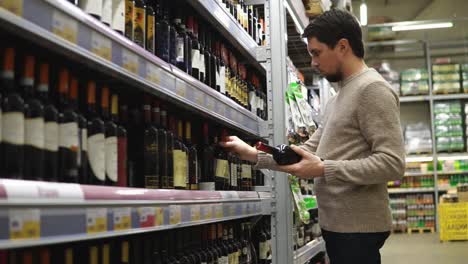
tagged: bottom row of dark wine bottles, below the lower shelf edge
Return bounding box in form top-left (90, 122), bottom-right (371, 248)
top-left (0, 218), bottom-right (271, 264)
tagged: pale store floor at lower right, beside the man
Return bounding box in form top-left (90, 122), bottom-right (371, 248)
top-left (380, 233), bottom-right (468, 264)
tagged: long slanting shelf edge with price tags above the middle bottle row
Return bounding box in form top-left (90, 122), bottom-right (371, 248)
top-left (0, 0), bottom-right (262, 136)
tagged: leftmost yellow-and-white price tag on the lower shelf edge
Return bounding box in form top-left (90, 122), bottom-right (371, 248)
top-left (9, 209), bottom-right (41, 239)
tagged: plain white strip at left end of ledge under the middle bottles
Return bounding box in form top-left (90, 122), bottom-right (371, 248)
top-left (0, 180), bottom-right (84, 202)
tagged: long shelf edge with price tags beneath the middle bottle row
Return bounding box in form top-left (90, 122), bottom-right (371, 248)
top-left (0, 180), bottom-right (264, 249)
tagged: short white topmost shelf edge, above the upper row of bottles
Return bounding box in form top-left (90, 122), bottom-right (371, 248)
top-left (189, 0), bottom-right (266, 73)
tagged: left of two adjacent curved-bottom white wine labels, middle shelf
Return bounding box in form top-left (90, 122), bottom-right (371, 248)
top-left (88, 133), bottom-right (106, 181)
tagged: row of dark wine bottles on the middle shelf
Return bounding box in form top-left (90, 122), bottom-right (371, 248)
top-left (0, 46), bottom-right (263, 190)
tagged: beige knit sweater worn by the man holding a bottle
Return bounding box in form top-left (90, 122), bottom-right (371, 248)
top-left (257, 68), bottom-right (405, 233)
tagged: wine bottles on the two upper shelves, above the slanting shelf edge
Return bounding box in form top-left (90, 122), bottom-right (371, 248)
top-left (68, 0), bottom-right (267, 119)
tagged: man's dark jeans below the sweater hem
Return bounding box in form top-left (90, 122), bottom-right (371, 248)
top-left (322, 229), bottom-right (390, 264)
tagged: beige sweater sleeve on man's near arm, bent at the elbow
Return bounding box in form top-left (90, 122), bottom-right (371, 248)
top-left (324, 82), bottom-right (405, 185)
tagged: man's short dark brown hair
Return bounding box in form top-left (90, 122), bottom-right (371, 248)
top-left (302, 9), bottom-right (364, 58)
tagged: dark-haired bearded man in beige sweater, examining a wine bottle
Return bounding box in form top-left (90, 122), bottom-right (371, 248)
top-left (222, 10), bottom-right (405, 264)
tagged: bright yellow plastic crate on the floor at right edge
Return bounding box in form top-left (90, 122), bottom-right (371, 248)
top-left (439, 203), bottom-right (468, 241)
